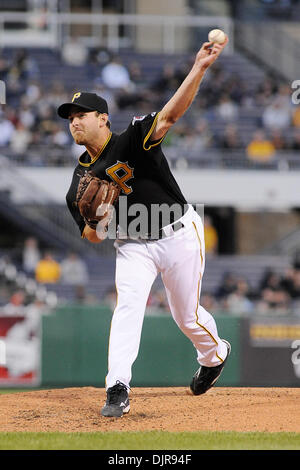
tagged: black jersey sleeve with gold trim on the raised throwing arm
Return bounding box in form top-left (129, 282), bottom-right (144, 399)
top-left (130, 112), bottom-right (165, 151)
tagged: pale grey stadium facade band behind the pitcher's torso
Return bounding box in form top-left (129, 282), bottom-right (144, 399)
top-left (14, 167), bottom-right (299, 211)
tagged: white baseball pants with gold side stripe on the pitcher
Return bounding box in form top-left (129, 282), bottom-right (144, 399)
top-left (106, 206), bottom-right (227, 389)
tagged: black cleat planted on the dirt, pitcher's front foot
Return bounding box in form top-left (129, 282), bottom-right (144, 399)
top-left (101, 381), bottom-right (130, 418)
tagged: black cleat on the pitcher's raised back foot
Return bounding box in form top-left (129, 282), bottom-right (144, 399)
top-left (190, 339), bottom-right (231, 395)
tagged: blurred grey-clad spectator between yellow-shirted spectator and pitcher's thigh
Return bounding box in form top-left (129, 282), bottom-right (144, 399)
top-left (60, 253), bottom-right (89, 286)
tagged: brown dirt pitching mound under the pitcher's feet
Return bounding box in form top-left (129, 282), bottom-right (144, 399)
top-left (0, 387), bottom-right (300, 432)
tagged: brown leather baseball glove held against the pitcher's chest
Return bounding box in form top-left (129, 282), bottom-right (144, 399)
top-left (75, 171), bottom-right (120, 230)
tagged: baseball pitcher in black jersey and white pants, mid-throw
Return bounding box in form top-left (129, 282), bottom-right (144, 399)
top-left (58, 37), bottom-right (230, 417)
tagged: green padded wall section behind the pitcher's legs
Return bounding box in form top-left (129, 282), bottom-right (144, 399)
top-left (42, 305), bottom-right (242, 387)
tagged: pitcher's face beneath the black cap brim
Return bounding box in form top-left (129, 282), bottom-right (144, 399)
top-left (69, 110), bottom-right (100, 145)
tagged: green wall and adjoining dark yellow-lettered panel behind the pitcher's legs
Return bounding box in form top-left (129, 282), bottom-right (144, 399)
top-left (41, 306), bottom-right (300, 387)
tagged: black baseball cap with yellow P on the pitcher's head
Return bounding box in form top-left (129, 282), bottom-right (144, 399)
top-left (57, 92), bottom-right (108, 119)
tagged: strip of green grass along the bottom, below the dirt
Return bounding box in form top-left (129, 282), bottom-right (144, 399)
top-left (0, 431), bottom-right (300, 450)
